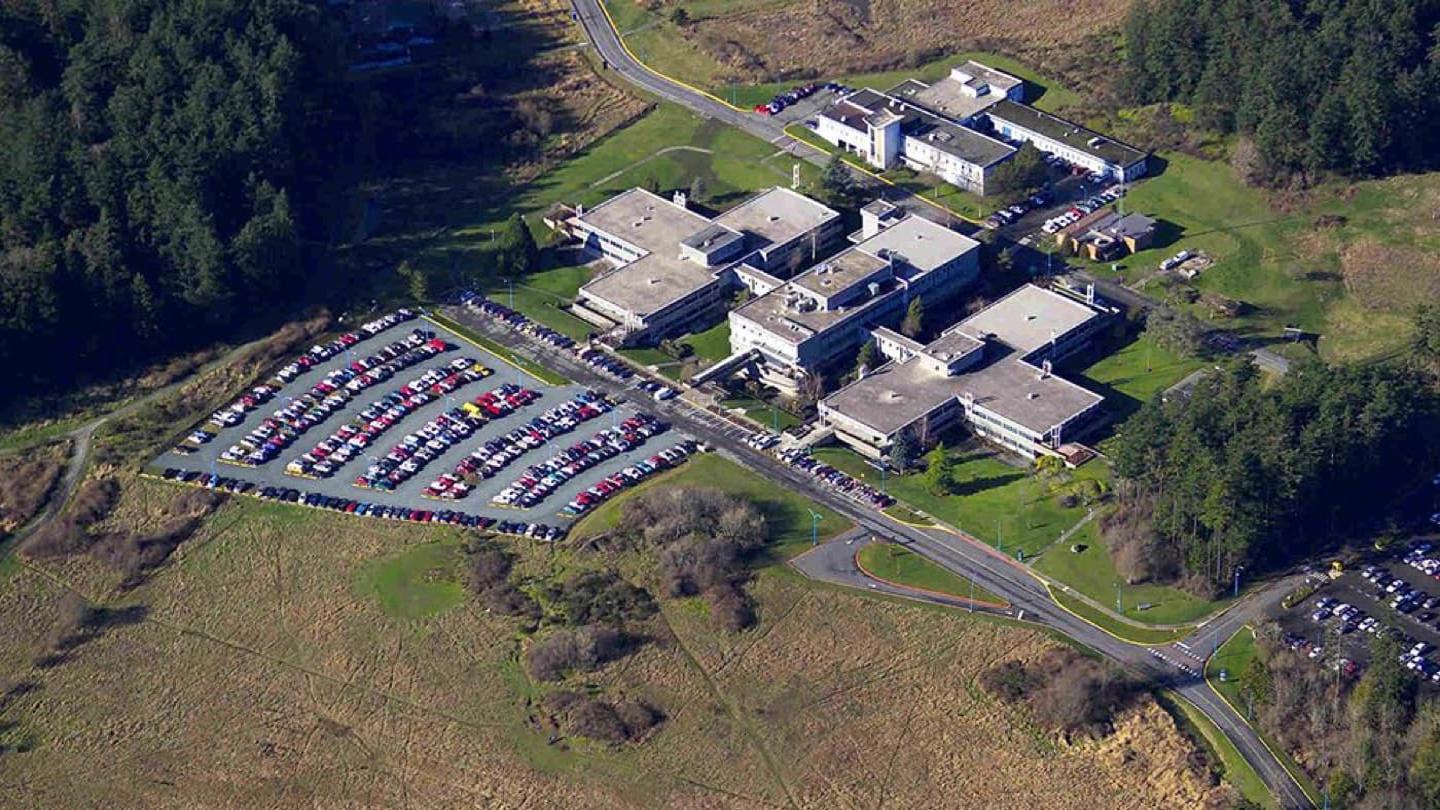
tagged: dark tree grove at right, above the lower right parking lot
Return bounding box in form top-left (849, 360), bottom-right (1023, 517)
top-left (1104, 362), bottom-right (1440, 592)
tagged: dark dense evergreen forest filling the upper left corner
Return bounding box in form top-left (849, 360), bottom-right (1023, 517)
top-left (0, 0), bottom-right (357, 399)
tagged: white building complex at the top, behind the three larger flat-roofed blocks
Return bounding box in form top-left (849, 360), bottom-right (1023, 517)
top-left (815, 62), bottom-right (1146, 195)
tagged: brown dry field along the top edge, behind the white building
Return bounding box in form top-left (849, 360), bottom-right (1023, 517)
top-left (606, 0), bottom-right (1129, 107)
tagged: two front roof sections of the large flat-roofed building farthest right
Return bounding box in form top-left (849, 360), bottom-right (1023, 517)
top-left (825, 344), bottom-right (1104, 435)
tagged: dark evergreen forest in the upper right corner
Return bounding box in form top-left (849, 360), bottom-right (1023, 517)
top-left (1120, 0), bottom-right (1440, 183)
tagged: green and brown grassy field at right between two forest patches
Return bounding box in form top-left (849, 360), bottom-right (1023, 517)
top-left (1105, 153), bottom-right (1440, 360)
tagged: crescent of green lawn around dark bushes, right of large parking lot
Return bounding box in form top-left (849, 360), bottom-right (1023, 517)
top-left (572, 453), bottom-right (851, 558)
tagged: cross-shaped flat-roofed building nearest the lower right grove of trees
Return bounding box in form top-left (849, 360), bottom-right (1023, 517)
top-left (819, 284), bottom-right (1115, 458)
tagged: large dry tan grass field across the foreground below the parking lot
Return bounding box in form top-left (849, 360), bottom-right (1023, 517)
top-left (0, 480), bottom-right (1225, 810)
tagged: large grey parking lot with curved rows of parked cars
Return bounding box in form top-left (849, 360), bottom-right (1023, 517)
top-left (153, 308), bottom-right (687, 525)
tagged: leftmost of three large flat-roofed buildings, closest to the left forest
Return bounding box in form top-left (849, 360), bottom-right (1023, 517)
top-left (563, 187), bottom-right (842, 344)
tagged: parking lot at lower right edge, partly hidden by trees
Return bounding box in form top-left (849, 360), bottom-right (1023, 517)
top-left (1279, 540), bottom-right (1440, 687)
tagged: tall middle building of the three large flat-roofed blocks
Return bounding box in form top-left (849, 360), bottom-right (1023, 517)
top-left (730, 206), bottom-right (979, 391)
